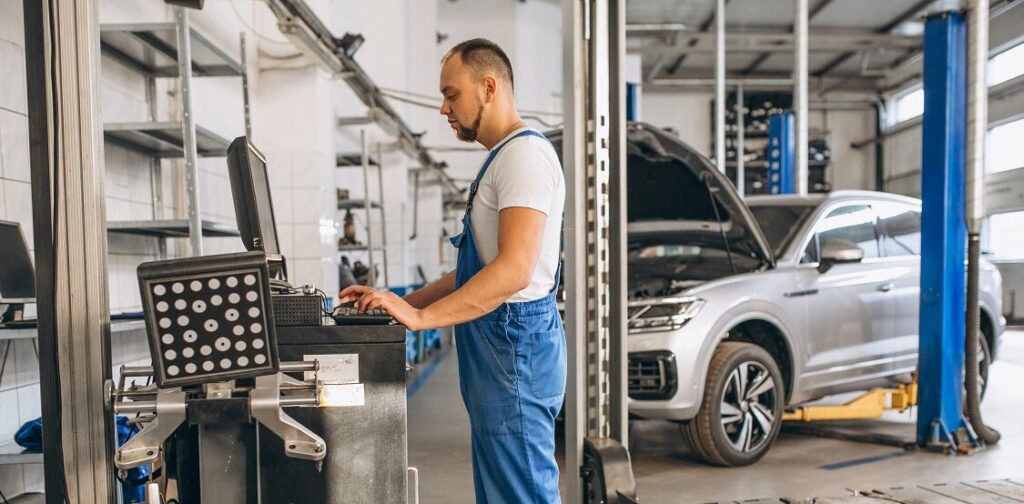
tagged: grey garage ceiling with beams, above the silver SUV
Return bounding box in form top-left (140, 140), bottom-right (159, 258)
top-left (626, 0), bottom-right (983, 92)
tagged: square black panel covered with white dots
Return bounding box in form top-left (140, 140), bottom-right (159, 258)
top-left (138, 252), bottom-right (280, 387)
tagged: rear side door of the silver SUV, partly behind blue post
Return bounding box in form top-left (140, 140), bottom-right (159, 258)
top-left (874, 202), bottom-right (921, 374)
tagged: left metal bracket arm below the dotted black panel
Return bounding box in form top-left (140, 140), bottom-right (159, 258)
top-left (114, 388), bottom-right (185, 469)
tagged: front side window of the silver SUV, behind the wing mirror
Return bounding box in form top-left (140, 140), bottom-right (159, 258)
top-left (801, 205), bottom-right (879, 262)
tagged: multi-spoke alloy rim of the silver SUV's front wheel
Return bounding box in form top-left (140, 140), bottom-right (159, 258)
top-left (720, 361), bottom-right (778, 453)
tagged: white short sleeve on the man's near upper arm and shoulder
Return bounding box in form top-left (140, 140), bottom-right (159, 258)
top-left (492, 141), bottom-right (559, 215)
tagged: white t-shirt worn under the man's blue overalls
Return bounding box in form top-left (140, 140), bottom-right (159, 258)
top-left (470, 128), bottom-right (565, 302)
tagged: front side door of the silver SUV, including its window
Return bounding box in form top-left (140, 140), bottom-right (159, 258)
top-left (802, 202), bottom-right (896, 393)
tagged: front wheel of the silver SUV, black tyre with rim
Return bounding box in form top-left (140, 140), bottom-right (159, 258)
top-left (680, 341), bottom-right (785, 467)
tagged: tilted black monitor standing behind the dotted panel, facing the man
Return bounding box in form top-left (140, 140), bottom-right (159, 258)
top-left (227, 136), bottom-right (281, 255)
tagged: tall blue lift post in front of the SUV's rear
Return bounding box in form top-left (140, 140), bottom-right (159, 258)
top-left (918, 8), bottom-right (973, 450)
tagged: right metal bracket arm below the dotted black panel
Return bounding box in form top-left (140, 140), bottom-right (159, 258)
top-left (249, 373), bottom-right (327, 469)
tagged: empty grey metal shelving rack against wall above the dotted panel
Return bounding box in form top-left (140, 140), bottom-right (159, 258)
top-left (100, 7), bottom-right (250, 256)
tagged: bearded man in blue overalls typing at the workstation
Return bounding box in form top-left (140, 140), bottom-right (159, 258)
top-left (341, 39), bottom-right (565, 504)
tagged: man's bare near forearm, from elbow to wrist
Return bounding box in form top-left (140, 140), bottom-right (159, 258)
top-left (423, 260), bottom-right (529, 328)
